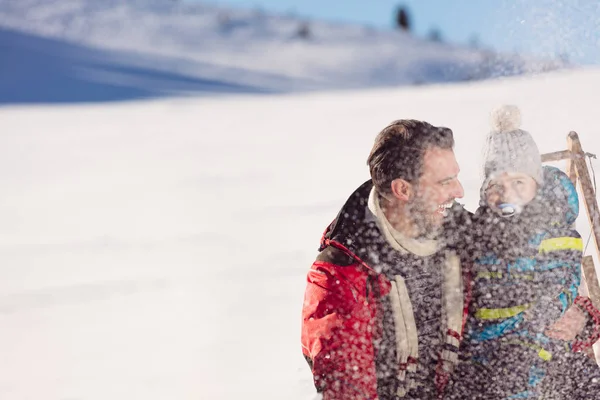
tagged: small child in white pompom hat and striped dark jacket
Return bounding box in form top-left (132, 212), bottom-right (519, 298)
top-left (445, 106), bottom-right (600, 400)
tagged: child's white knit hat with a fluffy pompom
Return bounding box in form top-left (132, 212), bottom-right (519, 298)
top-left (482, 105), bottom-right (544, 189)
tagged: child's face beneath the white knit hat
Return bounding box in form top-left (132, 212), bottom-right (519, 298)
top-left (485, 172), bottom-right (537, 214)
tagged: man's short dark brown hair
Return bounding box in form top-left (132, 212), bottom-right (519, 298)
top-left (367, 119), bottom-right (454, 194)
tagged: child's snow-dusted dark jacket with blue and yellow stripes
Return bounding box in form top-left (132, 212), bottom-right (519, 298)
top-left (465, 167), bottom-right (583, 359)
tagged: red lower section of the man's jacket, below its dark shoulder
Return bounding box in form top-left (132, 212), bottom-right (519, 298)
top-left (302, 241), bottom-right (390, 400)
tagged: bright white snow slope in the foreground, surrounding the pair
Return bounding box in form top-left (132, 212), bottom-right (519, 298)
top-left (0, 69), bottom-right (600, 400)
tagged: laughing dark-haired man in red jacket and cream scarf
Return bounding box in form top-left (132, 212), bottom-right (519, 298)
top-left (302, 120), bottom-right (469, 400)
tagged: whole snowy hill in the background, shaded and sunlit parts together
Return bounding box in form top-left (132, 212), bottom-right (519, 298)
top-left (0, 0), bottom-right (561, 104)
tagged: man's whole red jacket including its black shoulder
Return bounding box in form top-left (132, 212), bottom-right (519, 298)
top-left (302, 181), bottom-right (469, 400)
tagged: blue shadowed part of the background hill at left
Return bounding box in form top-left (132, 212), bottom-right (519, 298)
top-left (0, 28), bottom-right (266, 104)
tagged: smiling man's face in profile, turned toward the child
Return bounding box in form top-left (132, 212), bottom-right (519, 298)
top-left (408, 147), bottom-right (464, 236)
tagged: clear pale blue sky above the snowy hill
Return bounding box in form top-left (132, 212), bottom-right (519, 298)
top-left (196, 0), bottom-right (600, 64)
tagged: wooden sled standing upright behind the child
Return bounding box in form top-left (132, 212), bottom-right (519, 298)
top-left (542, 132), bottom-right (600, 360)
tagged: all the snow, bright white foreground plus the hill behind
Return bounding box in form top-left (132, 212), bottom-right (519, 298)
top-left (0, 0), bottom-right (600, 400)
